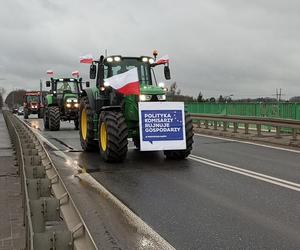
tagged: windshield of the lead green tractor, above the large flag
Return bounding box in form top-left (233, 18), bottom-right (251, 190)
top-left (104, 58), bottom-right (152, 85)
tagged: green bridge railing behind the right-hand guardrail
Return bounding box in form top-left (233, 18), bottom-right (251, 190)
top-left (186, 102), bottom-right (300, 120)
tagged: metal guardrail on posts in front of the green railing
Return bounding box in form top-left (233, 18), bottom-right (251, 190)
top-left (191, 114), bottom-right (300, 140)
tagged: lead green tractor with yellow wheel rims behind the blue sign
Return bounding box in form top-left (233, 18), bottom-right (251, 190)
top-left (79, 55), bottom-right (194, 162)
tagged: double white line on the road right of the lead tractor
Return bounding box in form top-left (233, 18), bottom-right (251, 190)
top-left (188, 155), bottom-right (300, 192)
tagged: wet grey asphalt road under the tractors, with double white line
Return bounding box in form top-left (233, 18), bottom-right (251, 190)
top-left (21, 115), bottom-right (300, 249)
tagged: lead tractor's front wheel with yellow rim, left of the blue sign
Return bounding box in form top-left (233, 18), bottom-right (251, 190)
top-left (98, 111), bottom-right (128, 162)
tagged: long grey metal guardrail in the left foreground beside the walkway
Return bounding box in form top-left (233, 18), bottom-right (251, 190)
top-left (3, 111), bottom-right (98, 250)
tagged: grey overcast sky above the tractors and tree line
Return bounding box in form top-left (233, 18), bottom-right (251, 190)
top-left (0, 0), bottom-right (300, 98)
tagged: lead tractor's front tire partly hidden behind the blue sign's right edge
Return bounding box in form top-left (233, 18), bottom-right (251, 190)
top-left (164, 114), bottom-right (194, 160)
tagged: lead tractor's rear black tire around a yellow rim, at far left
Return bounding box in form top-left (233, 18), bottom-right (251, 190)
top-left (79, 96), bottom-right (99, 152)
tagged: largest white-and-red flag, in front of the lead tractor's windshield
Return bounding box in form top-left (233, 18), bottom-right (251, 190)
top-left (104, 68), bottom-right (140, 96)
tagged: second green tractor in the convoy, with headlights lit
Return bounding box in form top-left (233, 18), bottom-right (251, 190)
top-left (44, 78), bottom-right (89, 131)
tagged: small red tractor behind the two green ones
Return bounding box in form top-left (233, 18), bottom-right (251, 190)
top-left (23, 91), bottom-right (44, 119)
